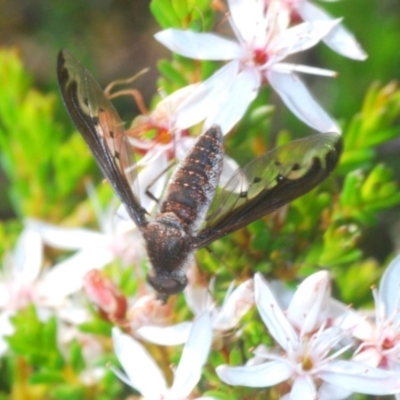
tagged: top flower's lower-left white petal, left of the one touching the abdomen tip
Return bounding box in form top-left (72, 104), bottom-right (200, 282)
top-left (176, 61), bottom-right (239, 129)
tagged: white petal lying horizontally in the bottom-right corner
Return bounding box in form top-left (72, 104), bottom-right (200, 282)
top-left (318, 360), bottom-right (400, 395)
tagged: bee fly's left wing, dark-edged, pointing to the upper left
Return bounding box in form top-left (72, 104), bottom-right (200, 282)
top-left (57, 50), bottom-right (146, 227)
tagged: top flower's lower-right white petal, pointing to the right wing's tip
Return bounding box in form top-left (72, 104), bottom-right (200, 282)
top-left (267, 71), bottom-right (340, 133)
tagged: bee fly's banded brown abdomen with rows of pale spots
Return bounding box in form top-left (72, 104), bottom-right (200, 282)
top-left (160, 126), bottom-right (224, 231)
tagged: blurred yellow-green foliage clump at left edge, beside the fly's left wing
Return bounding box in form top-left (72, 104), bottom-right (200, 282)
top-left (0, 50), bottom-right (92, 221)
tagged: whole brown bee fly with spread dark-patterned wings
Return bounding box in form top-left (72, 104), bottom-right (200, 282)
top-left (57, 50), bottom-right (341, 303)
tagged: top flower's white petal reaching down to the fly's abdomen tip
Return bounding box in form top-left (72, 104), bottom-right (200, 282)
top-left (204, 68), bottom-right (261, 134)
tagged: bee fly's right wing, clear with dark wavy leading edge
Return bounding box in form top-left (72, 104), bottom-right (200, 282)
top-left (193, 133), bottom-right (342, 248)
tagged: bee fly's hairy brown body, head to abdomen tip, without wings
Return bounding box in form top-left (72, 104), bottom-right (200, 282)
top-left (143, 128), bottom-right (224, 293)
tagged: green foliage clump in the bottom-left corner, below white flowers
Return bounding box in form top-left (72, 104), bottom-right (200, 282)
top-left (0, 306), bottom-right (121, 400)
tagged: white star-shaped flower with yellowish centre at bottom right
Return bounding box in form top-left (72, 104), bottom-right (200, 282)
top-left (217, 271), bottom-right (400, 400)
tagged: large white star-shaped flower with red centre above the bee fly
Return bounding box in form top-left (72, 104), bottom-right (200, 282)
top-left (155, 0), bottom-right (340, 133)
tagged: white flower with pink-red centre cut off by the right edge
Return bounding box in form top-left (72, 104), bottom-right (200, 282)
top-left (353, 256), bottom-right (400, 373)
